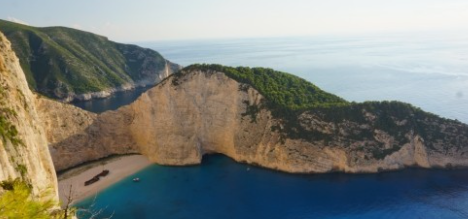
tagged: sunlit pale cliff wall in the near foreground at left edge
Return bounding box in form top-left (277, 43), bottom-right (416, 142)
top-left (0, 33), bottom-right (57, 197)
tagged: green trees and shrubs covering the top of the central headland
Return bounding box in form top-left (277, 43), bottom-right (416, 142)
top-left (179, 64), bottom-right (459, 159)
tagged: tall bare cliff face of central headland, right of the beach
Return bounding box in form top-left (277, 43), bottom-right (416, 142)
top-left (123, 71), bottom-right (468, 173)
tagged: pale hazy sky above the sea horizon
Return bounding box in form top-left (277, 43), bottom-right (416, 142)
top-left (0, 0), bottom-right (468, 42)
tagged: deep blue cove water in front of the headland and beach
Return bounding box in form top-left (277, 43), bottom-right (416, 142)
top-left (78, 155), bottom-right (468, 219)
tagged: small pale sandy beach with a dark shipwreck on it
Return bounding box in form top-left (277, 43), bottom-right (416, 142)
top-left (58, 155), bottom-right (151, 204)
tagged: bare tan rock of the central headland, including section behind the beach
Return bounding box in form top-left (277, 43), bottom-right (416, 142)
top-left (41, 71), bottom-right (468, 173)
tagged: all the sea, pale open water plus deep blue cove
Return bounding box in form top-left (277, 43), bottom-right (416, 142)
top-left (76, 33), bottom-right (468, 219)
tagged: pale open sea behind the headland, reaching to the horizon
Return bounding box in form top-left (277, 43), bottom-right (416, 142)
top-left (145, 33), bottom-right (468, 123)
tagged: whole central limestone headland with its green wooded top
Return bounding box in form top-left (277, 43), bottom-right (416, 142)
top-left (41, 66), bottom-right (468, 173)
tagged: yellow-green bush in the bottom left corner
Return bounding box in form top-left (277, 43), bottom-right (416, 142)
top-left (0, 179), bottom-right (74, 219)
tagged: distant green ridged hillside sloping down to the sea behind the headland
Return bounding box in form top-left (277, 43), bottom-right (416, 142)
top-left (0, 20), bottom-right (180, 101)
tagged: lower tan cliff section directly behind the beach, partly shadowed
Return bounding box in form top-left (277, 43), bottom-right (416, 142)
top-left (36, 96), bottom-right (139, 171)
